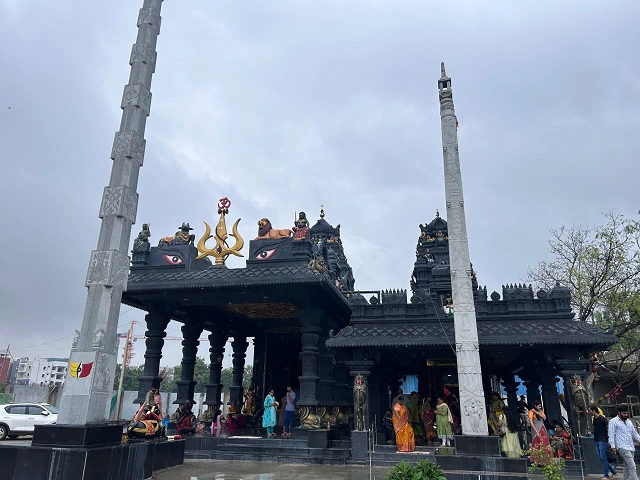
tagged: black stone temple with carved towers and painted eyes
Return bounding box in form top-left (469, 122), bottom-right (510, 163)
top-left (123, 203), bottom-right (617, 458)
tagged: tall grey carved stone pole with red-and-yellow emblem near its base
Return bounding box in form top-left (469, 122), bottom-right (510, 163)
top-left (58, 0), bottom-right (162, 425)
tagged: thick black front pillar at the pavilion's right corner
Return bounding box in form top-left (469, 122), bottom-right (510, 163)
top-left (298, 309), bottom-right (322, 407)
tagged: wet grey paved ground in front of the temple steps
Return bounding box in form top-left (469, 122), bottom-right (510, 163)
top-left (153, 460), bottom-right (388, 480)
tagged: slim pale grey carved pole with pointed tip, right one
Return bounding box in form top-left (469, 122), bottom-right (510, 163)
top-left (438, 63), bottom-right (488, 436)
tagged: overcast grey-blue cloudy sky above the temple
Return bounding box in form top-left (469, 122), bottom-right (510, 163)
top-left (0, 0), bottom-right (640, 365)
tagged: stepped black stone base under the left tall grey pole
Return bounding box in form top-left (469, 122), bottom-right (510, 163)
top-left (0, 424), bottom-right (185, 480)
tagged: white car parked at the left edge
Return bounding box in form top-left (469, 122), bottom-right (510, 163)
top-left (0, 403), bottom-right (58, 440)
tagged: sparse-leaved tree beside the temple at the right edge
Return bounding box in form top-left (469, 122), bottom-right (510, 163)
top-left (527, 212), bottom-right (640, 386)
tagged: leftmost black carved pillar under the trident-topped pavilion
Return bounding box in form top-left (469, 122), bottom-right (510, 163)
top-left (136, 313), bottom-right (171, 404)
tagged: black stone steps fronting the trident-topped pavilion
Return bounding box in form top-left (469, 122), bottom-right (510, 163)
top-left (185, 433), bottom-right (350, 465)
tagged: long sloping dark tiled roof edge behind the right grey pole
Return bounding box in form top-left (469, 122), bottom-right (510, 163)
top-left (327, 319), bottom-right (618, 348)
